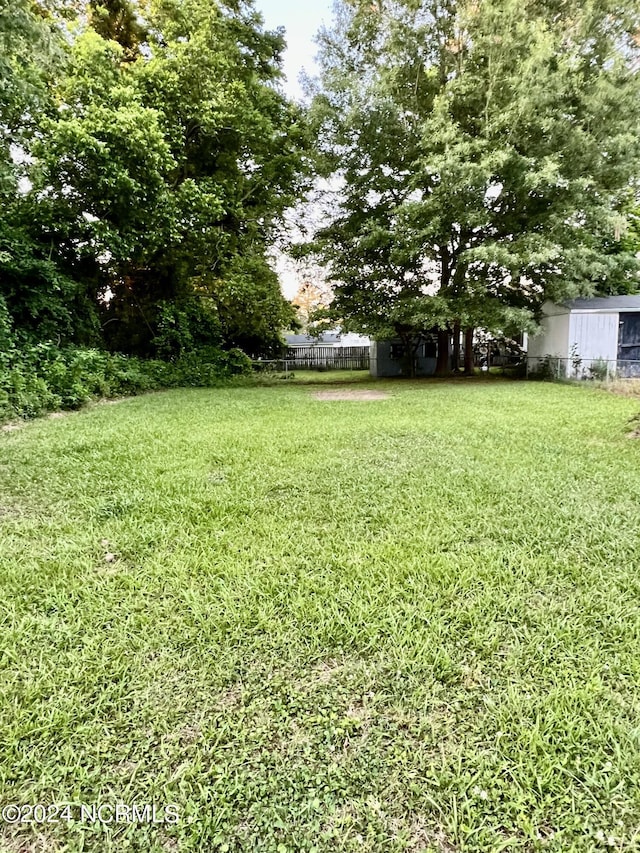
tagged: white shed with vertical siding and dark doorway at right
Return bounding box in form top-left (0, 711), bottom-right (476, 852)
top-left (527, 295), bottom-right (640, 378)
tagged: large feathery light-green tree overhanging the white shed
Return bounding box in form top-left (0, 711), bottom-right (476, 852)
top-left (314, 0), bottom-right (640, 373)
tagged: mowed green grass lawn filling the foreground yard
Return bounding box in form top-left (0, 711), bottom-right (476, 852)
top-left (0, 380), bottom-right (640, 853)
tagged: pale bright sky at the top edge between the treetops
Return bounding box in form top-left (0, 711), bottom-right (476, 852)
top-left (254, 0), bottom-right (332, 99)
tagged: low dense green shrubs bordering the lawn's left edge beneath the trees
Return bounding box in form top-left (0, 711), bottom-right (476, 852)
top-left (0, 340), bottom-right (251, 420)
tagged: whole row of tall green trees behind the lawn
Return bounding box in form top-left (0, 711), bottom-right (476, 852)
top-left (0, 0), bottom-right (640, 373)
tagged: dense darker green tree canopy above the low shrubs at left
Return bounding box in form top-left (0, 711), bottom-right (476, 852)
top-left (0, 0), bottom-right (307, 355)
